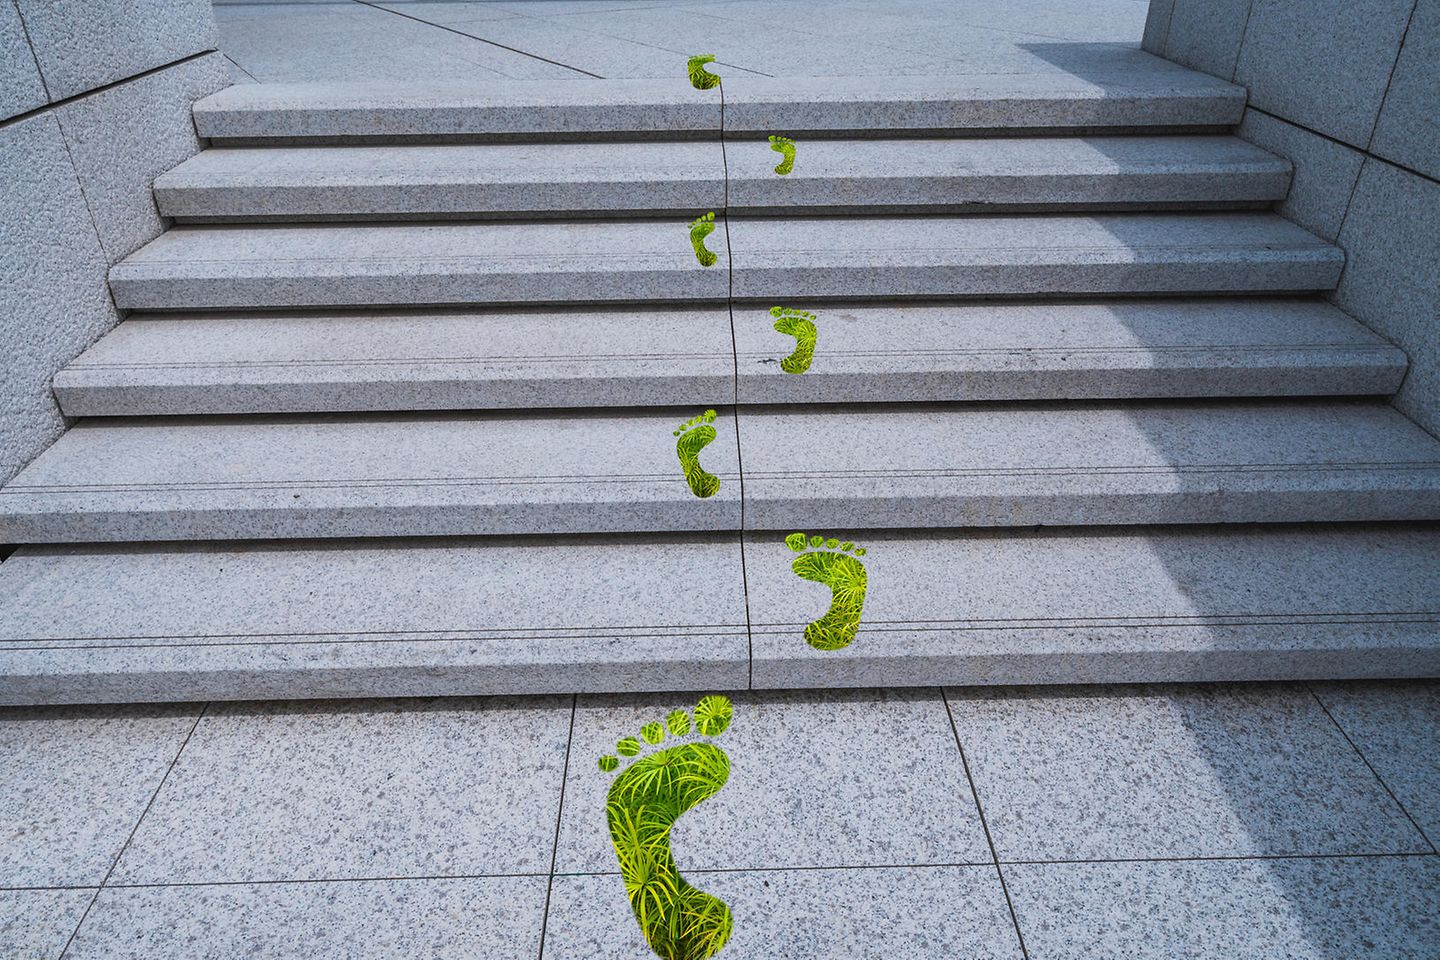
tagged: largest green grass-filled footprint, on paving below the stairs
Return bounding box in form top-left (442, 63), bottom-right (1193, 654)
top-left (599, 695), bottom-right (734, 960)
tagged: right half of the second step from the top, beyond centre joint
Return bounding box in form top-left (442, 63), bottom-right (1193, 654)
top-left (726, 128), bottom-right (1290, 213)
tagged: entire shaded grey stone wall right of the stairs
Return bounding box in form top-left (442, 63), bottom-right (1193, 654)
top-left (1143, 0), bottom-right (1440, 433)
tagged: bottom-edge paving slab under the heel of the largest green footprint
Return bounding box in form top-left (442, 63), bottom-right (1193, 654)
top-left (544, 866), bottom-right (1021, 960)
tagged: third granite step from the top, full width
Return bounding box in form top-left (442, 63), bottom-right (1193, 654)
top-left (109, 213), bottom-right (1345, 311)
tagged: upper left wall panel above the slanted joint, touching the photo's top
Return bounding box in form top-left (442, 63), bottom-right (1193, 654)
top-left (17, 0), bottom-right (217, 101)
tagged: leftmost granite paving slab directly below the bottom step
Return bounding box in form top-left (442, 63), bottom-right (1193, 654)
top-left (0, 704), bottom-right (200, 886)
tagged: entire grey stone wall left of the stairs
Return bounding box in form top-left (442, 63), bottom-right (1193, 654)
top-left (0, 0), bottom-right (229, 484)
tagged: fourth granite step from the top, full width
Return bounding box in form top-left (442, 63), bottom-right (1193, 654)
top-left (55, 299), bottom-right (1405, 416)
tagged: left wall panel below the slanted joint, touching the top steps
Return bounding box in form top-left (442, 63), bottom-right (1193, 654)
top-left (56, 53), bottom-right (229, 263)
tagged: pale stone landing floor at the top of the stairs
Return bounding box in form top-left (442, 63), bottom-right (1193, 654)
top-left (215, 0), bottom-right (1149, 82)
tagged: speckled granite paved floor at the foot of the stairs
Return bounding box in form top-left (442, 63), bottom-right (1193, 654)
top-left (0, 682), bottom-right (1440, 960)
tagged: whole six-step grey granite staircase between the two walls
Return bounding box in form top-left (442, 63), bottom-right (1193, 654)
top-left (0, 50), bottom-right (1440, 704)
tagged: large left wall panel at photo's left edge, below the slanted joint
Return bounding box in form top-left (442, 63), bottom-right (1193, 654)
top-left (0, 112), bottom-right (118, 482)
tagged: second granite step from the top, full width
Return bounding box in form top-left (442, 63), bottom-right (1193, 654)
top-left (154, 137), bottom-right (1290, 223)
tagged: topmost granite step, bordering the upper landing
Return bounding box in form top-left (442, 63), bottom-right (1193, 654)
top-left (194, 57), bottom-right (1246, 144)
